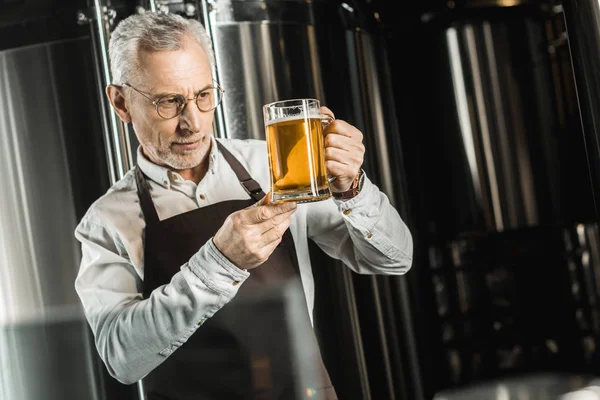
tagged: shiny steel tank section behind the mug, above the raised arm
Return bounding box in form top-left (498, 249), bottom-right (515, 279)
top-left (204, 0), bottom-right (406, 200)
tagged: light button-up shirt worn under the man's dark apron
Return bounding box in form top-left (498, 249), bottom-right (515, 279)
top-left (75, 138), bottom-right (413, 384)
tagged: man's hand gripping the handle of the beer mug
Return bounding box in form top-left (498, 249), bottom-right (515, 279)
top-left (321, 106), bottom-right (365, 192)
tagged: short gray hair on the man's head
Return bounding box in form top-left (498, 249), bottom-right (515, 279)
top-left (108, 11), bottom-right (215, 85)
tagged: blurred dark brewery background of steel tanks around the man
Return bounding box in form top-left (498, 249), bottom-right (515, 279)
top-left (0, 0), bottom-right (600, 400)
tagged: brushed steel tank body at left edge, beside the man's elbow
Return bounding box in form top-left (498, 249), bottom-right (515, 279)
top-left (0, 39), bottom-right (107, 400)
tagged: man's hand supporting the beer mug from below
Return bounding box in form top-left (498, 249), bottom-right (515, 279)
top-left (213, 193), bottom-right (297, 269)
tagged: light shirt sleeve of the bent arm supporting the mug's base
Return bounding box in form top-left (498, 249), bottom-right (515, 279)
top-left (75, 219), bottom-right (249, 384)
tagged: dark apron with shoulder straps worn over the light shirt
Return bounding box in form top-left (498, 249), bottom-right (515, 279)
top-left (135, 142), bottom-right (337, 400)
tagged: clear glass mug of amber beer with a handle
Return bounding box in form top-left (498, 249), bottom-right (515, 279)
top-left (263, 99), bottom-right (333, 203)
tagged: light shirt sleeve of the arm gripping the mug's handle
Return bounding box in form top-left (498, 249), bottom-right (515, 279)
top-left (307, 175), bottom-right (413, 275)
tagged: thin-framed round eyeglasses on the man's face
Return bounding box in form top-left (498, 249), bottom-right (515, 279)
top-left (123, 82), bottom-right (225, 119)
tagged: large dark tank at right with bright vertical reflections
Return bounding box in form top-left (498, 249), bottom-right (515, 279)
top-left (383, 0), bottom-right (600, 398)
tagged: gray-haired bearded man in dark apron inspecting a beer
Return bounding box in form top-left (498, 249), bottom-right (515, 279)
top-left (75, 13), bottom-right (412, 400)
